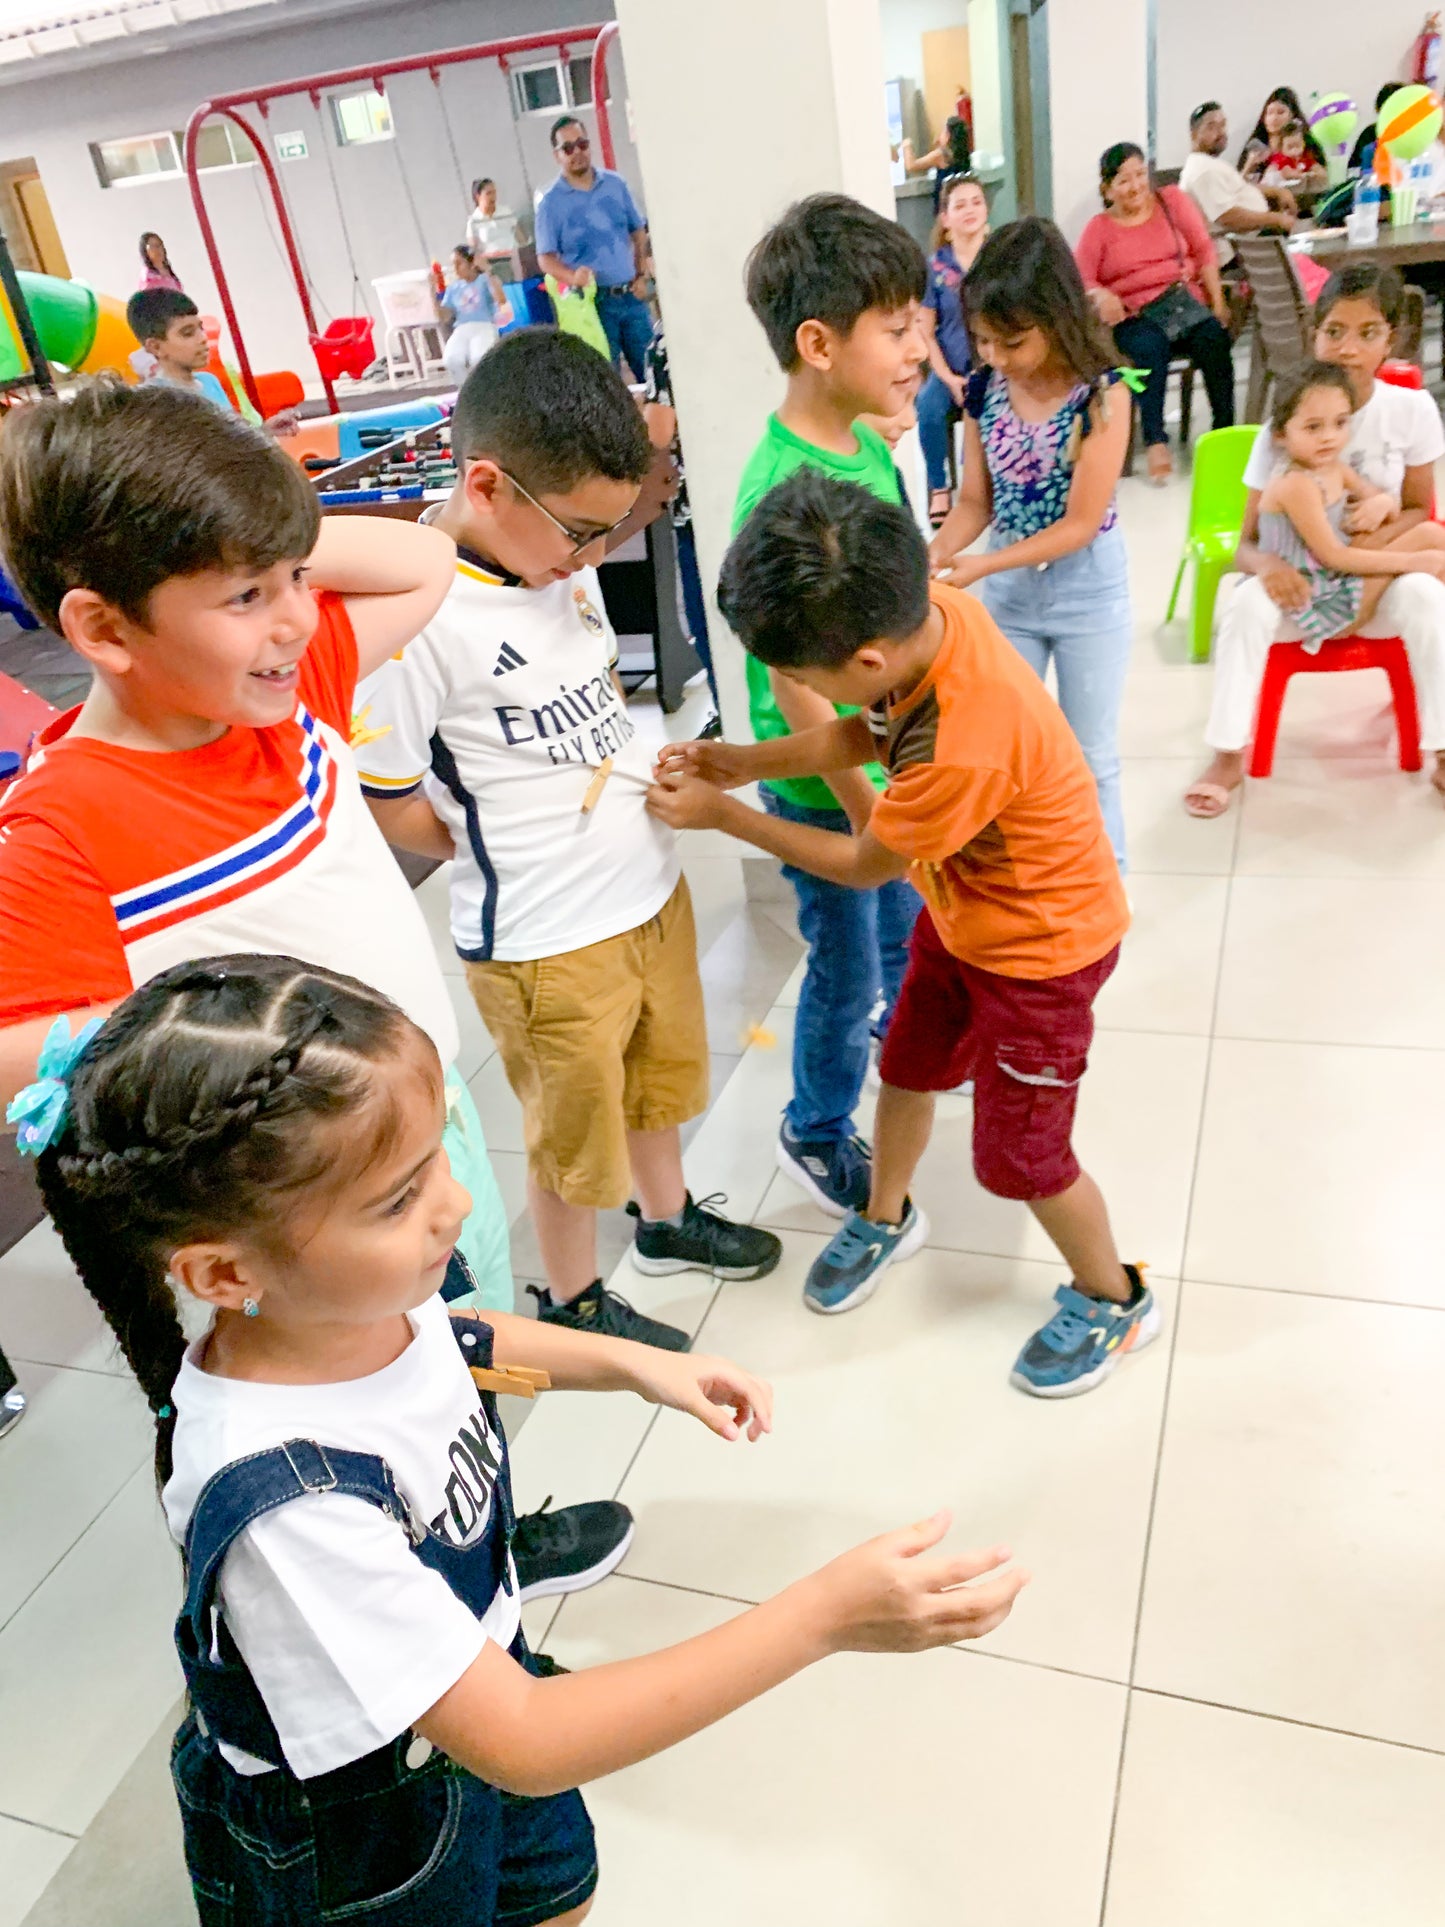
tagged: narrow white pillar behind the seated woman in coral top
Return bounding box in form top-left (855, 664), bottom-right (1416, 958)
top-left (1048, 0), bottom-right (1148, 241)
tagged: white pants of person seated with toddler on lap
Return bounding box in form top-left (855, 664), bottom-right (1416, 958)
top-left (1204, 576), bottom-right (1445, 753)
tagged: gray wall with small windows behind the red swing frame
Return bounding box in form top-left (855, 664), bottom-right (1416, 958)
top-left (0, 0), bottom-right (642, 382)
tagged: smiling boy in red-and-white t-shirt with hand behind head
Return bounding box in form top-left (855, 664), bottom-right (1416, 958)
top-left (0, 383), bottom-right (632, 1597)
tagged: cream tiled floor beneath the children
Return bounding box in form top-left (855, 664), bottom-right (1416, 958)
top-left (0, 466), bottom-right (1445, 1927)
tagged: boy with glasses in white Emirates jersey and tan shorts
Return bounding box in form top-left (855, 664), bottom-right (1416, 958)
top-left (358, 328), bottom-right (780, 1351)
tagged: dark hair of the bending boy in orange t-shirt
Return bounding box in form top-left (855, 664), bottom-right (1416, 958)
top-left (717, 468), bottom-right (929, 669)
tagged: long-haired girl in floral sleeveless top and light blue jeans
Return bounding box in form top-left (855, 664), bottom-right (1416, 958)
top-left (933, 216), bottom-right (1133, 869)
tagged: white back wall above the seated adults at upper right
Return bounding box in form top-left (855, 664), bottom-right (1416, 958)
top-left (1163, 0), bottom-right (1424, 168)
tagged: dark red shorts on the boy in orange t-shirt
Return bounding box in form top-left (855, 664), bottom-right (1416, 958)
top-left (879, 910), bottom-right (1119, 1199)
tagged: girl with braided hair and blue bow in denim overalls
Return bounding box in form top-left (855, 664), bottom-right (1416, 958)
top-left (22, 956), bottom-right (1023, 1927)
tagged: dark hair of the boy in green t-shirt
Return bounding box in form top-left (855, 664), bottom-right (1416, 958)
top-left (744, 195), bottom-right (929, 374)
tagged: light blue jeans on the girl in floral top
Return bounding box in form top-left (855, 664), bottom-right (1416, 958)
top-left (977, 522), bottom-right (1135, 871)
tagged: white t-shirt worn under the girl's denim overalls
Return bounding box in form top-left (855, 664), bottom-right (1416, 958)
top-left (162, 1297), bottom-right (520, 1779)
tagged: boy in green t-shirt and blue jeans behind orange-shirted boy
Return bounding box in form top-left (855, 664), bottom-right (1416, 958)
top-left (732, 195), bottom-right (929, 1218)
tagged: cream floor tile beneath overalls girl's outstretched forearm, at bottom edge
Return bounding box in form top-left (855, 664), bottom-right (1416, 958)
top-left (549, 1582), bottom-right (1123, 1927)
